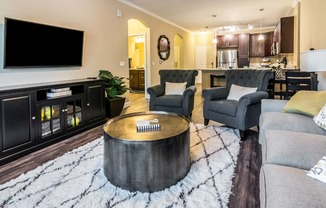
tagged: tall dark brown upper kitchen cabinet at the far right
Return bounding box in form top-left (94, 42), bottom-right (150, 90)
top-left (274, 16), bottom-right (294, 54)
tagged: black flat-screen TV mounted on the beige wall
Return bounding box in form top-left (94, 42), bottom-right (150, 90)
top-left (3, 18), bottom-right (84, 68)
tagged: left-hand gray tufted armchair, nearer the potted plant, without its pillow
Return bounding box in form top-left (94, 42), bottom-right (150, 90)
top-left (147, 70), bottom-right (198, 117)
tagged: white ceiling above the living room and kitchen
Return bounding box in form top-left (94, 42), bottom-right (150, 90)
top-left (118, 0), bottom-right (299, 32)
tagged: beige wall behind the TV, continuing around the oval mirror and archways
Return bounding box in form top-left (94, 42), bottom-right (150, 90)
top-left (0, 0), bottom-right (194, 87)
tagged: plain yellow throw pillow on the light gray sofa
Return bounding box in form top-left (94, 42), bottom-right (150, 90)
top-left (282, 90), bottom-right (326, 117)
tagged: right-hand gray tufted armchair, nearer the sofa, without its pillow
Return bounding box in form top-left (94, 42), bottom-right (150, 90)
top-left (203, 69), bottom-right (272, 138)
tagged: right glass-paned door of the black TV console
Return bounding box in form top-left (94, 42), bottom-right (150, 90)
top-left (66, 99), bottom-right (83, 129)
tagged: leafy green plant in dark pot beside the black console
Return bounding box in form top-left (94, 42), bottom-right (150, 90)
top-left (98, 70), bottom-right (129, 118)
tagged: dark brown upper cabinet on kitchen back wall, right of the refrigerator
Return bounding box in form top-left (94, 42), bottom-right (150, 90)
top-left (250, 32), bottom-right (273, 57)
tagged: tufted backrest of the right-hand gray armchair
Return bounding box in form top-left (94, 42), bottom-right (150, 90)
top-left (225, 69), bottom-right (272, 91)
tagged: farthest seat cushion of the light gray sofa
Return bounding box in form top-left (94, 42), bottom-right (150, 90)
top-left (259, 112), bottom-right (326, 145)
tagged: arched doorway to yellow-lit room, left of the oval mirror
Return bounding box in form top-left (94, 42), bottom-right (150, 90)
top-left (128, 19), bottom-right (151, 98)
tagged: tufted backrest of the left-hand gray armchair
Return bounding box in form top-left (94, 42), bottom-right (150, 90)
top-left (159, 69), bottom-right (198, 87)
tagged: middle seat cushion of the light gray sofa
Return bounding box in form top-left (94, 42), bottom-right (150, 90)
top-left (262, 130), bottom-right (326, 170)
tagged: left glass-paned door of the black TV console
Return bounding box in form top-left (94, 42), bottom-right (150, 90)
top-left (40, 104), bottom-right (62, 138)
